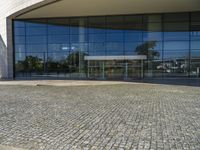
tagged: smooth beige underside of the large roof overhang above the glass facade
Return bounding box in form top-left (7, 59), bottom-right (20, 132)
top-left (16, 0), bottom-right (200, 19)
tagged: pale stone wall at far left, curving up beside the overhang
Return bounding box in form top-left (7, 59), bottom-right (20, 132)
top-left (0, 0), bottom-right (56, 79)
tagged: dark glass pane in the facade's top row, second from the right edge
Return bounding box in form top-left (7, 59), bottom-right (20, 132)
top-left (164, 13), bottom-right (189, 22)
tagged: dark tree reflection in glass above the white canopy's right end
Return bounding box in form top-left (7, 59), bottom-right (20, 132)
top-left (135, 41), bottom-right (160, 60)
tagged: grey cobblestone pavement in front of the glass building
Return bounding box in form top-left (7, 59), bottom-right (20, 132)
top-left (0, 84), bottom-right (200, 150)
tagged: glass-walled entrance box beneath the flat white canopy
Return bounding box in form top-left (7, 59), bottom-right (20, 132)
top-left (88, 60), bottom-right (143, 80)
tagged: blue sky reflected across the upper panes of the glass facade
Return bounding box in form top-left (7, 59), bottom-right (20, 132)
top-left (15, 15), bottom-right (200, 57)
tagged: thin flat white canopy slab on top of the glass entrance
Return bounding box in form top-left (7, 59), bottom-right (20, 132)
top-left (84, 55), bottom-right (147, 61)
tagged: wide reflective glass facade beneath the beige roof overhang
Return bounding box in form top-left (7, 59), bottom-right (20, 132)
top-left (14, 12), bottom-right (200, 79)
